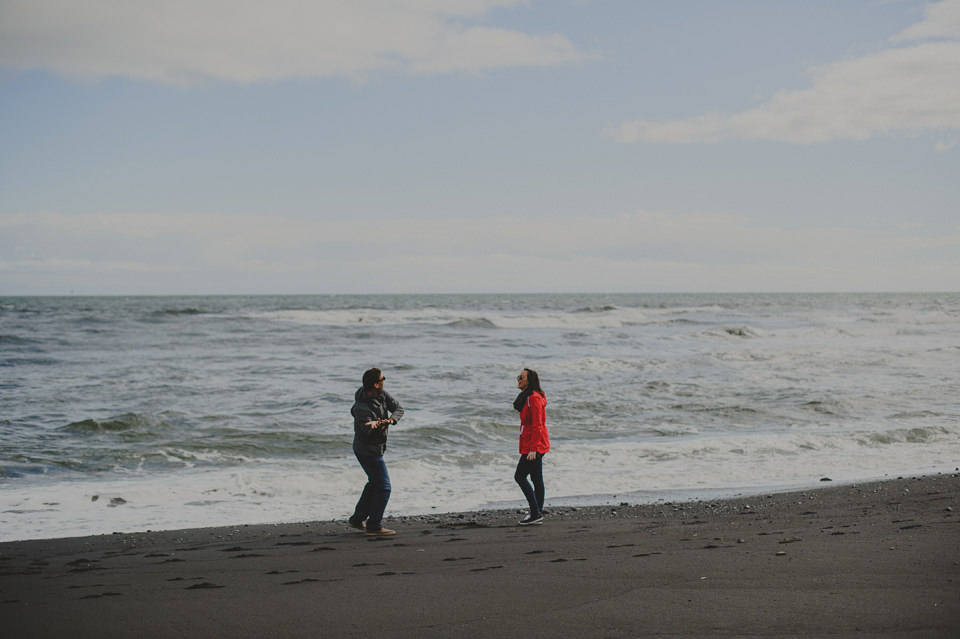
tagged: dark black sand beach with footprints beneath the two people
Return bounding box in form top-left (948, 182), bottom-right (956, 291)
top-left (0, 474), bottom-right (960, 639)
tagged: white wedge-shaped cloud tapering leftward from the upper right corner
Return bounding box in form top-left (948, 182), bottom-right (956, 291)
top-left (604, 0), bottom-right (960, 144)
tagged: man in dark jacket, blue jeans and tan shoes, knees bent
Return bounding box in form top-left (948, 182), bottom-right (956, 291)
top-left (349, 368), bottom-right (403, 537)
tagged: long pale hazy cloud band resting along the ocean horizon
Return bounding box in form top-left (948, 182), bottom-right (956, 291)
top-left (0, 211), bottom-right (960, 294)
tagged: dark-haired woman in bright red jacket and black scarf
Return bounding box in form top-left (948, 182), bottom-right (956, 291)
top-left (513, 368), bottom-right (550, 526)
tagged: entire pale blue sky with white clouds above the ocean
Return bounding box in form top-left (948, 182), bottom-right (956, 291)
top-left (0, 0), bottom-right (960, 295)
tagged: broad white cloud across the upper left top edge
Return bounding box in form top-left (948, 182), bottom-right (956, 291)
top-left (0, 0), bottom-right (585, 86)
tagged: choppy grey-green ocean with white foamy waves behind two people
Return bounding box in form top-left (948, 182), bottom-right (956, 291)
top-left (0, 293), bottom-right (960, 541)
